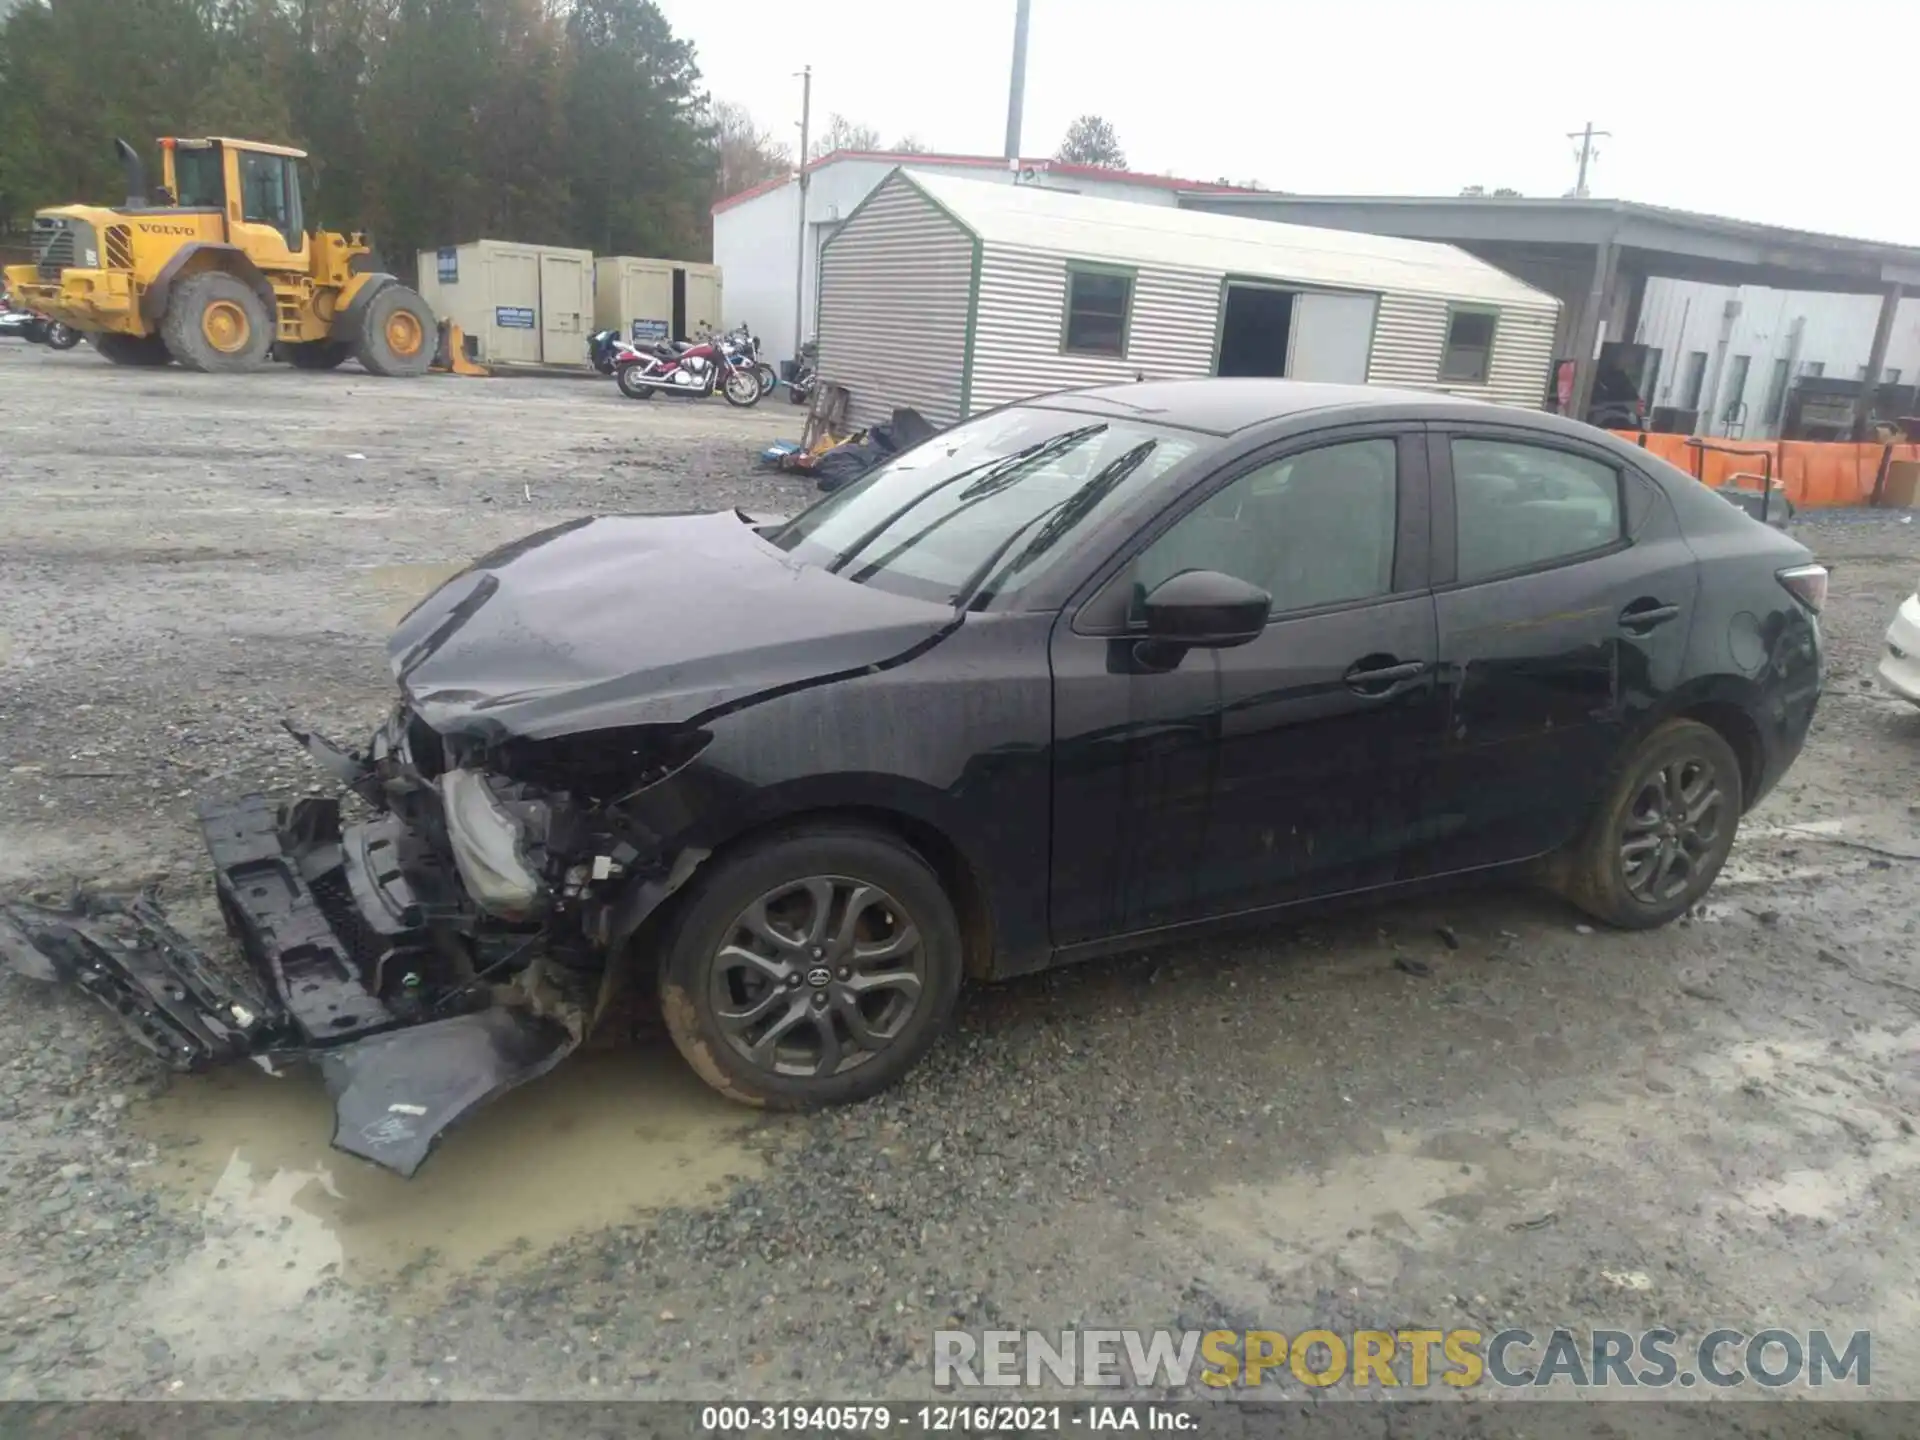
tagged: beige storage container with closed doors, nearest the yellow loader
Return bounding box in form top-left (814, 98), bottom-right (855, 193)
top-left (420, 240), bottom-right (593, 365)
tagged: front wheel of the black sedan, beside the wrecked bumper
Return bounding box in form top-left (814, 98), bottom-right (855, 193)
top-left (660, 828), bottom-right (964, 1110)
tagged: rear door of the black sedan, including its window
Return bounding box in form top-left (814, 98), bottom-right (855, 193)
top-left (1413, 416), bottom-right (1699, 874)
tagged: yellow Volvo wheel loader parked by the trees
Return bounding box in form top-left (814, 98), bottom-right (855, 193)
top-left (6, 138), bottom-right (438, 374)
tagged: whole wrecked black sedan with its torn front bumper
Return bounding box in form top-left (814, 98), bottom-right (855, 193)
top-left (0, 380), bottom-right (1826, 1173)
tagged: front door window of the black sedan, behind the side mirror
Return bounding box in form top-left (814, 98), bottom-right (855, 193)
top-left (1131, 438), bottom-right (1398, 614)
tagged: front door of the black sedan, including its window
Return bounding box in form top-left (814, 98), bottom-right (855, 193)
top-left (1050, 426), bottom-right (1440, 947)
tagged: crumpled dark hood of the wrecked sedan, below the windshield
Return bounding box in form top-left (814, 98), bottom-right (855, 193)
top-left (388, 511), bottom-right (958, 739)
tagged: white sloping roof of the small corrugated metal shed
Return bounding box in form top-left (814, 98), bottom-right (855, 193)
top-left (897, 169), bottom-right (1559, 307)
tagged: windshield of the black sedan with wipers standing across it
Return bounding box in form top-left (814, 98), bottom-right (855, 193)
top-left (772, 409), bottom-right (1200, 605)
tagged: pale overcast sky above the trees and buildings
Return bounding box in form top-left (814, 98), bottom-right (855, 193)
top-left (660, 0), bottom-right (1920, 246)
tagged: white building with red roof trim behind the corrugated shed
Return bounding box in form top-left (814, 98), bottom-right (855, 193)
top-left (714, 150), bottom-right (1240, 361)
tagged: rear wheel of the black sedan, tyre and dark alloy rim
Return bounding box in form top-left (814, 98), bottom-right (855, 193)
top-left (1555, 720), bottom-right (1745, 929)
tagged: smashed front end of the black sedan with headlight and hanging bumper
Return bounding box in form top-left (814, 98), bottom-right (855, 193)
top-left (0, 701), bottom-right (705, 1175)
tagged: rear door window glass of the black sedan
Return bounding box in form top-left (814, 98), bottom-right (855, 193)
top-left (1453, 438), bottom-right (1624, 584)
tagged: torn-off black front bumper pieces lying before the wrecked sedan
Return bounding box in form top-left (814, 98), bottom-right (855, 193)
top-left (0, 795), bottom-right (584, 1175)
